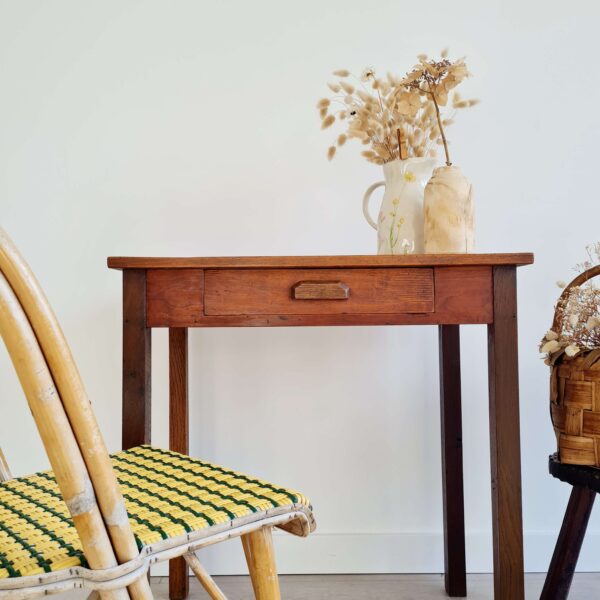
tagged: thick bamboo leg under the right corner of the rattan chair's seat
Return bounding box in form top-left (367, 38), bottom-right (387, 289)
top-left (242, 527), bottom-right (281, 600)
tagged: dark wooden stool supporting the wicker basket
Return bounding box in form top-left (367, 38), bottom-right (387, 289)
top-left (540, 454), bottom-right (600, 600)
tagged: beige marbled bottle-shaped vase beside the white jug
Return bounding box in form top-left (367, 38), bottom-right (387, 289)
top-left (423, 166), bottom-right (475, 254)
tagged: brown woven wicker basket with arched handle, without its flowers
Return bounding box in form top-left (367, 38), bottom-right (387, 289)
top-left (550, 265), bottom-right (600, 467)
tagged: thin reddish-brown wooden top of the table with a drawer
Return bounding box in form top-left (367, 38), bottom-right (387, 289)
top-left (107, 252), bottom-right (533, 269)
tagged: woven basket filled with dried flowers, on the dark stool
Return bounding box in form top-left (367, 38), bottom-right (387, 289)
top-left (540, 243), bottom-right (600, 467)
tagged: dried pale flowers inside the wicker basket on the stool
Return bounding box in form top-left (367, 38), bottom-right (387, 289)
top-left (540, 242), bottom-right (600, 365)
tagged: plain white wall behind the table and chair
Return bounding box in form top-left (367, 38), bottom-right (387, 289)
top-left (0, 0), bottom-right (600, 572)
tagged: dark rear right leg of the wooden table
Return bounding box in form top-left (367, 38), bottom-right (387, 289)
top-left (439, 325), bottom-right (467, 596)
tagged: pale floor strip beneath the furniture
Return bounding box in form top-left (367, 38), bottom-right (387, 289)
top-left (54, 573), bottom-right (600, 600)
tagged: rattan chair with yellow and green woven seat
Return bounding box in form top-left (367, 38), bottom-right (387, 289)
top-left (0, 230), bottom-right (315, 600)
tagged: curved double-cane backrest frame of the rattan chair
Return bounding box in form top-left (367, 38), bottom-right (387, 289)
top-left (0, 229), bottom-right (149, 599)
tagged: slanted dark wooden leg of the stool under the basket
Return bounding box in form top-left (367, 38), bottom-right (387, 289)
top-left (540, 486), bottom-right (596, 600)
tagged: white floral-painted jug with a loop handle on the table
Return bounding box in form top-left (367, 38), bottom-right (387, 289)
top-left (363, 158), bottom-right (437, 254)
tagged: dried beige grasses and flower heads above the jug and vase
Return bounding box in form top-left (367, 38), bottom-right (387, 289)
top-left (317, 51), bottom-right (477, 165)
